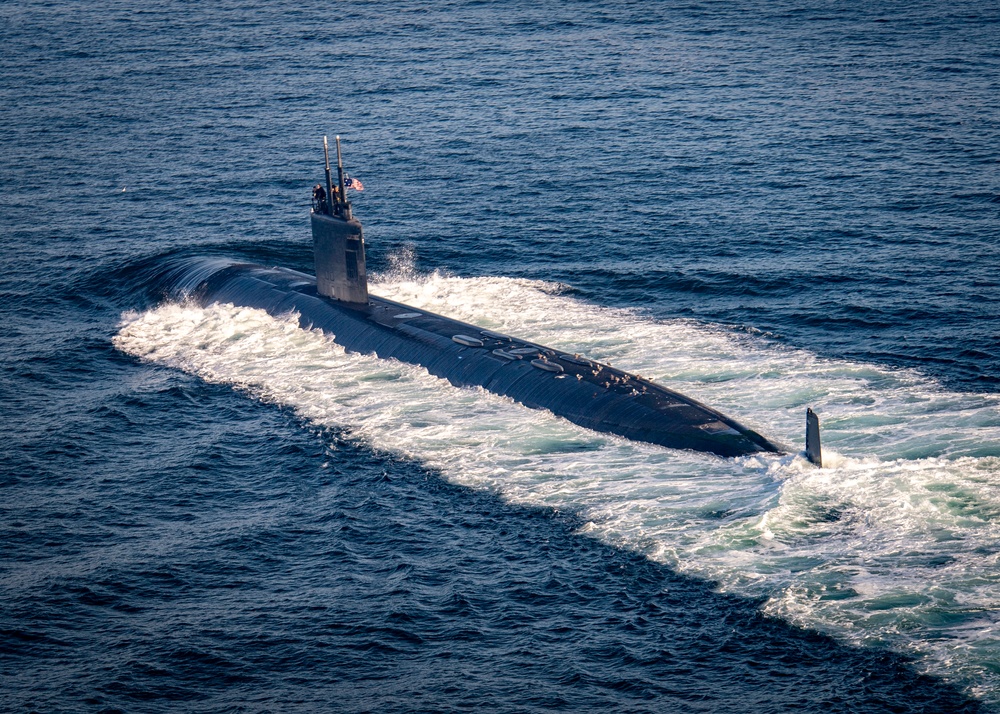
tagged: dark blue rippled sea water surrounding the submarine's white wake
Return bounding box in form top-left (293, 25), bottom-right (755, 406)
top-left (0, 1), bottom-right (1000, 712)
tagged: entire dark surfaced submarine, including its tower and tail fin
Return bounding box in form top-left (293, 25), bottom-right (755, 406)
top-left (165, 136), bottom-right (822, 465)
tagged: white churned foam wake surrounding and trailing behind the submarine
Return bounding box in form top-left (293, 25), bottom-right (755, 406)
top-left (114, 275), bottom-right (1000, 703)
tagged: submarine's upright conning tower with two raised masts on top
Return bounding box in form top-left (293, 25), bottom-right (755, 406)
top-left (312, 136), bottom-right (368, 304)
